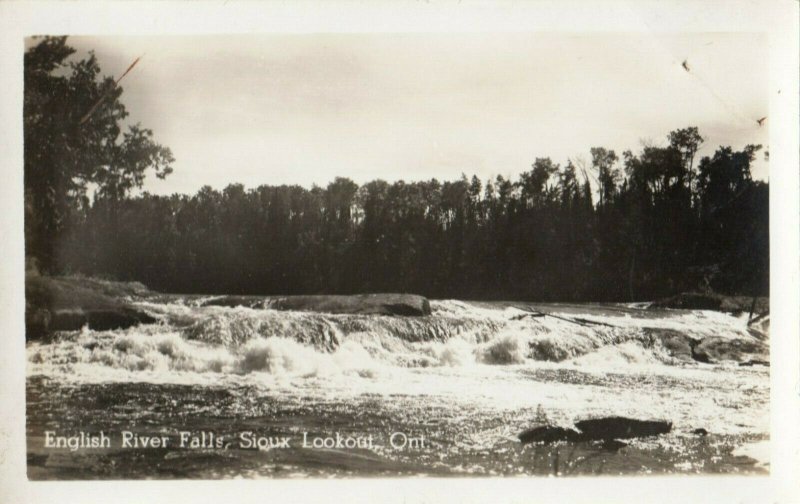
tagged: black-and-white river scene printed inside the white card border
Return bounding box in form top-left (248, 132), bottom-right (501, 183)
top-left (3, 0), bottom-right (798, 500)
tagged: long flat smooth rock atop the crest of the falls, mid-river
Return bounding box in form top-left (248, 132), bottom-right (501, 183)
top-left (266, 294), bottom-right (431, 317)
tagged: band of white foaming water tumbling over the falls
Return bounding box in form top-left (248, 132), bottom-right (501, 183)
top-left (27, 301), bottom-right (766, 382)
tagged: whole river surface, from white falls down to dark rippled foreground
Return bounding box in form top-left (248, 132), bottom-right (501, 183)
top-left (27, 296), bottom-right (769, 479)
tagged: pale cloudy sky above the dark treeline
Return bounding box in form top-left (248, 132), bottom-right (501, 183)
top-left (45, 33), bottom-right (769, 194)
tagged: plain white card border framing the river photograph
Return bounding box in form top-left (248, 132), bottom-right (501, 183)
top-left (0, 0), bottom-right (800, 503)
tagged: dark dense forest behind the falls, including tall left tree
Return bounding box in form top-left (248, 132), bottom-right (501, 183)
top-left (25, 38), bottom-right (769, 301)
